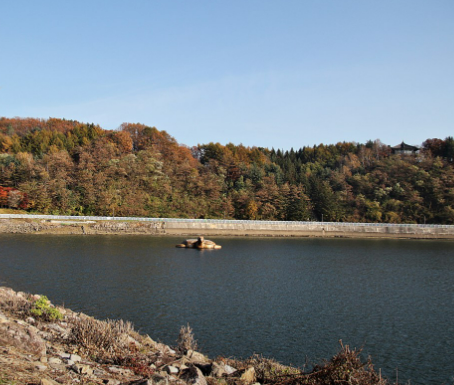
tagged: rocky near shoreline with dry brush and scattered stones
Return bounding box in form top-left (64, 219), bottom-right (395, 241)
top-left (0, 287), bottom-right (389, 385)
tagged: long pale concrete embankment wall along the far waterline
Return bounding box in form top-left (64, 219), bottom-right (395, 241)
top-left (0, 214), bottom-right (454, 239)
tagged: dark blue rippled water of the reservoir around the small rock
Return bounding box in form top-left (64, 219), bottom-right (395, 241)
top-left (0, 234), bottom-right (454, 384)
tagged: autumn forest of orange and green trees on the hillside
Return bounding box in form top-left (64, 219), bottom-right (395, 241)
top-left (0, 117), bottom-right (454, 224)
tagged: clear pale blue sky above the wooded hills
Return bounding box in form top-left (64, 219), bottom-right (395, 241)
top-left (0, 0), bottom-right (454, 150)
